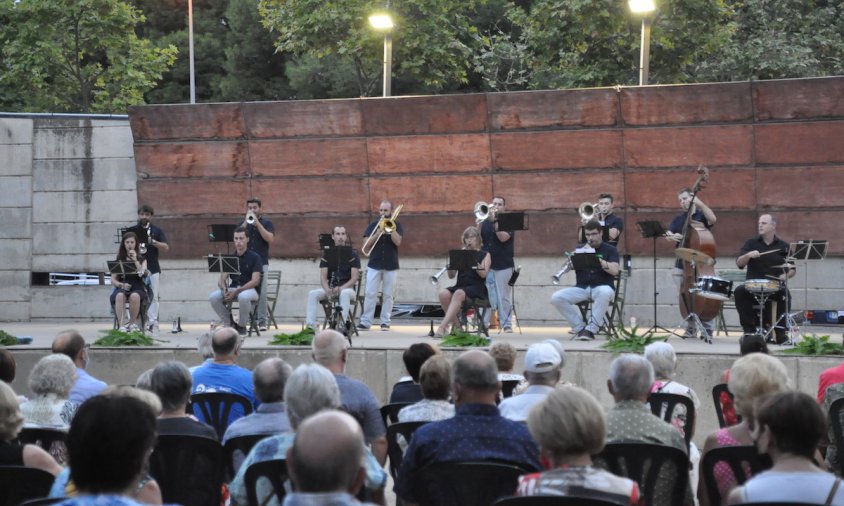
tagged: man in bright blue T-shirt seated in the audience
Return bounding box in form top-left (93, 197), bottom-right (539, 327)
top-left (193, 327), bottom-right (257, 424)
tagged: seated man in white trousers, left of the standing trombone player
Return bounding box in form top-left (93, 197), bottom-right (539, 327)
top-left (305, 226), bottom-right (360, 332)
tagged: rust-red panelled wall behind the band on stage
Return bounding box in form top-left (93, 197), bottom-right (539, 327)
top-left (130, 77), bottom-right (844, 257)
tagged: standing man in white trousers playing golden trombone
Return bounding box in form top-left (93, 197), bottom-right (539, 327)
top-left (358, 200), bottom-right (404, 330)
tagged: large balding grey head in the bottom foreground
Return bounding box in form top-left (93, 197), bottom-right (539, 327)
top-left (284, 410), bottom-right (366, 506)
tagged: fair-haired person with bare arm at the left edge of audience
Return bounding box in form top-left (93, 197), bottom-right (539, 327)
top-left (0, 381), bottom-right (62, 475)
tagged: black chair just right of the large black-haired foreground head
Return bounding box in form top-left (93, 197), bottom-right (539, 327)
top-left (149, 435), bottom-right (223, 506)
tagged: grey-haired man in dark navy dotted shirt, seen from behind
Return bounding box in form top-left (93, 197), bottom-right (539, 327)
top-left (394, 350), bottom-right (542, 502)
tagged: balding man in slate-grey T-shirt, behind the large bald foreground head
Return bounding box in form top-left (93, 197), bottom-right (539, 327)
top-left (312, 330), bottom-right (387, 465)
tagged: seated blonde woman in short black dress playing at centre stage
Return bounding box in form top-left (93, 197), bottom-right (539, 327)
top-left (434, 227), bottom-right (492, 339)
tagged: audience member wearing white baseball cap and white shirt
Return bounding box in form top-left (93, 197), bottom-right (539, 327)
top-left (498, 342), bottom-right (563, 422)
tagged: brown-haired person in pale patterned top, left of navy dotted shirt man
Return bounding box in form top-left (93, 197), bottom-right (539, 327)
top-left (398, 355), bottom-right (454, 422)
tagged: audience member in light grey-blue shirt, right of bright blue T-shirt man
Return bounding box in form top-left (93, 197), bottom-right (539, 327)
top-left (223, 357), bottom-right (293, 444)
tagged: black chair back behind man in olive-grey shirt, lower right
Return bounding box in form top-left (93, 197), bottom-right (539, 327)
top-left (593, 443), bottom-right (689, 506)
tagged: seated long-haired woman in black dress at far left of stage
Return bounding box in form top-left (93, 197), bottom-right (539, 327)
top-left (110, 232), bottom-right (148, 332)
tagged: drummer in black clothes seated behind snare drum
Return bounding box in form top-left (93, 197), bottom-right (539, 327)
top-left (733, 214), bottom-right (797, 344)
